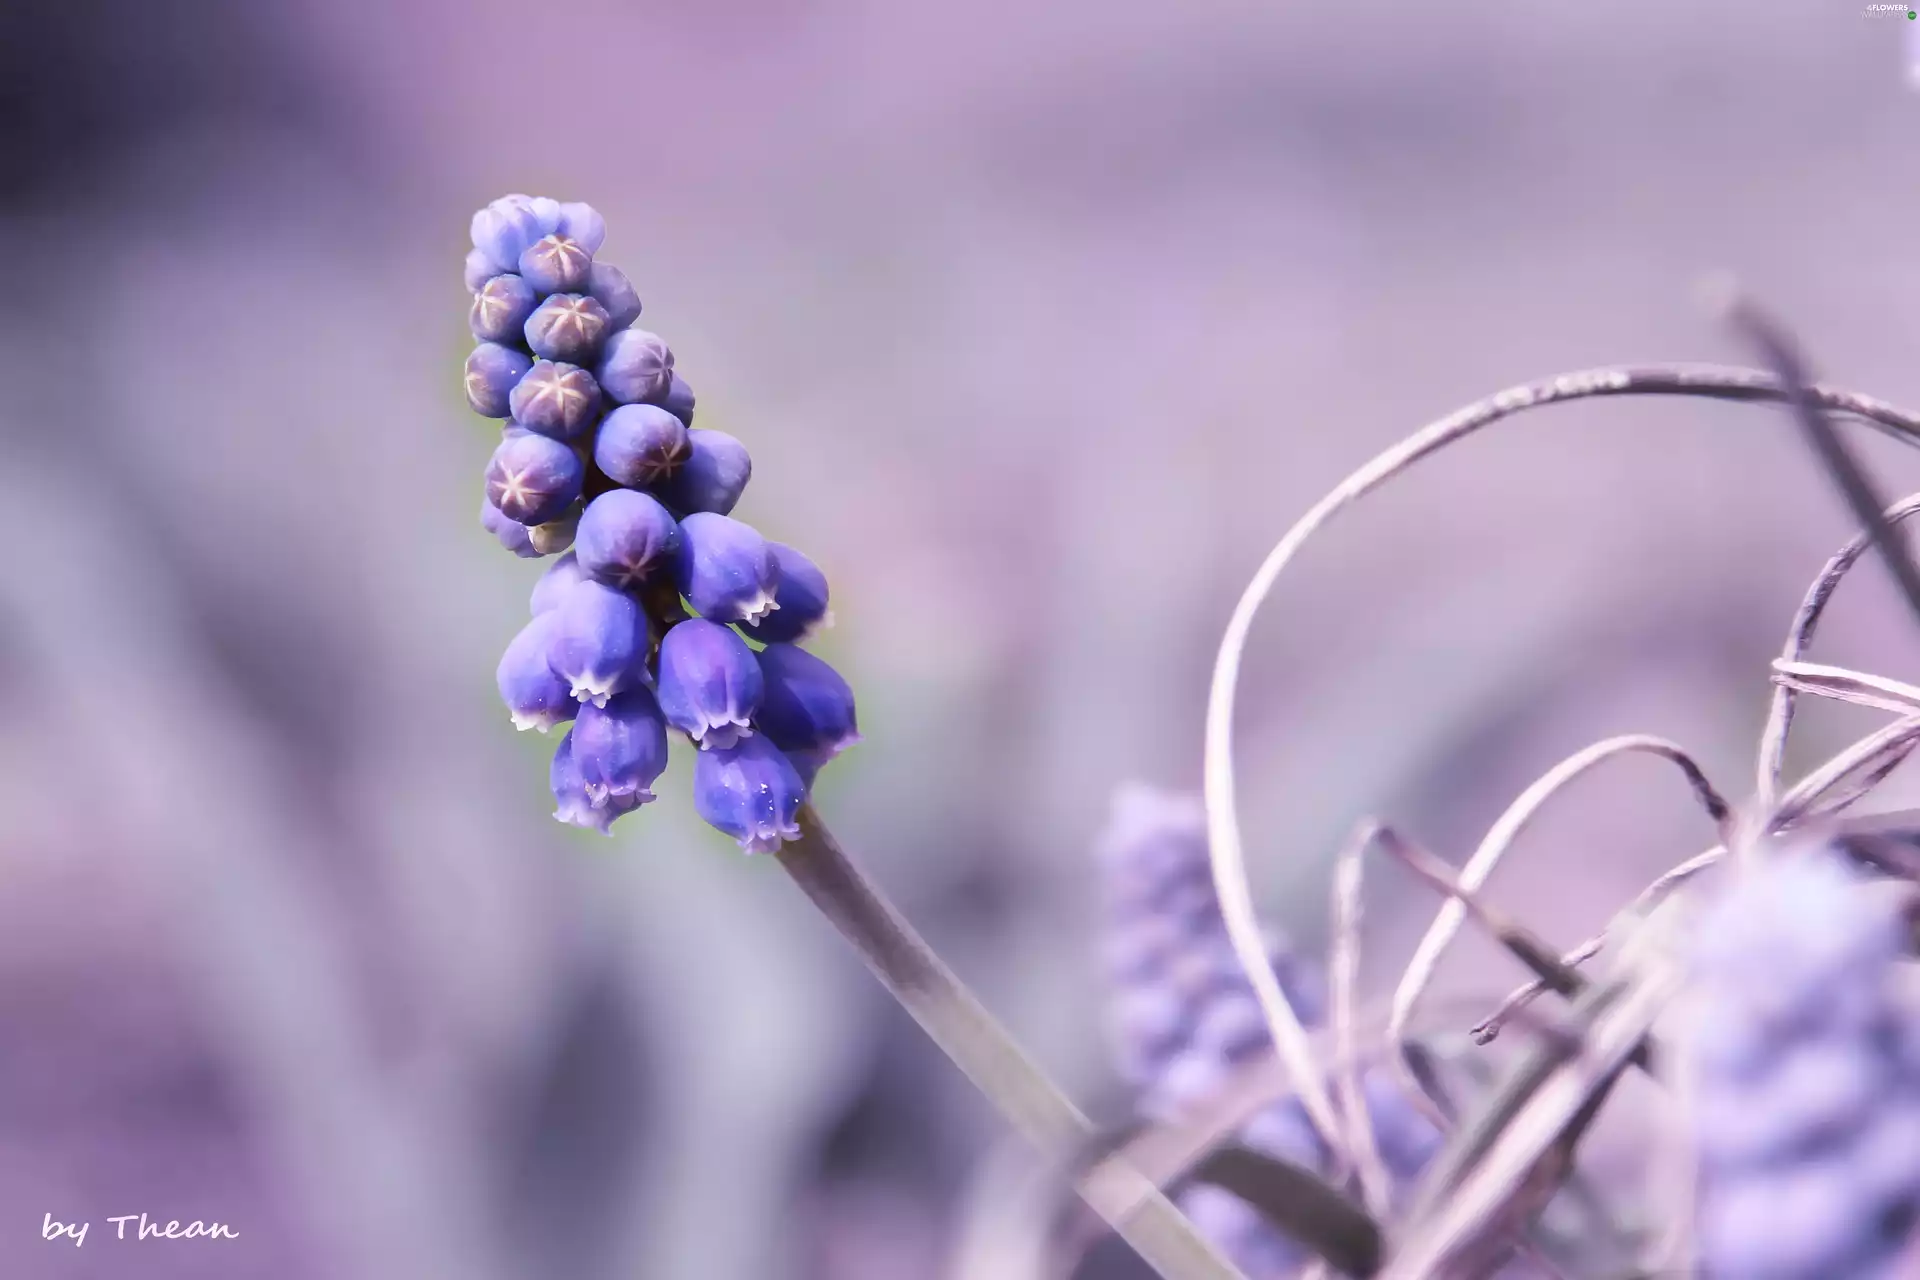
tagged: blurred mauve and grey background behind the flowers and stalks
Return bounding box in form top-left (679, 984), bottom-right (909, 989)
top-left (0, 0), bottom-right (1920, 1280)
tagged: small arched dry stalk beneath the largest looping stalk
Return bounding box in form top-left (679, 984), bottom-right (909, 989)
top-left (1386, 733), bottom-right (1734, 1113)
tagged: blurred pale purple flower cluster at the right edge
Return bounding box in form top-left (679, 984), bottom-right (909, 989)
top-left (1686, 844), bottom-right (1920, 1280)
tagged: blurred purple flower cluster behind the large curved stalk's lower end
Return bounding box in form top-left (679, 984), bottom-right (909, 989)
top-left (1096, 783), bottom-right (1440, 1280)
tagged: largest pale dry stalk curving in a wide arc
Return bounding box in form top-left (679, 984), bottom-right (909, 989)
top-left (1204, 365), bottom-right (1920, 1148)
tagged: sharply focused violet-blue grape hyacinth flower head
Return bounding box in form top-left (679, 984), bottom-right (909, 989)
top-left (467, 196), bottom-right (858, 852)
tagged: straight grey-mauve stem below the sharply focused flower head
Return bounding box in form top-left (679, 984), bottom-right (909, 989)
top-left (778, 804), bottom-right (1242, 1280)
